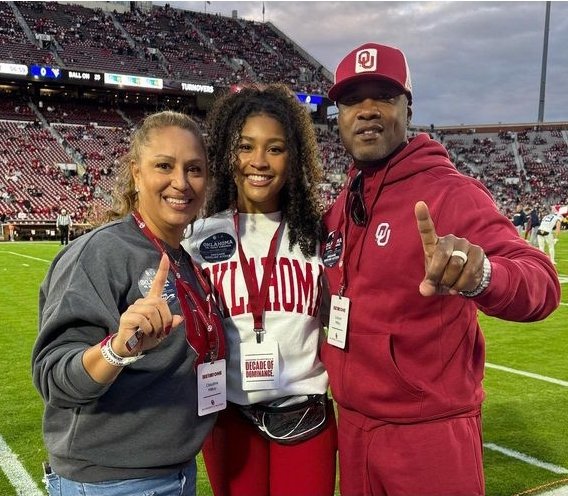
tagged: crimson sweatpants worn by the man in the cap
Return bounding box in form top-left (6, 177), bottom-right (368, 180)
top-left (338, 408), bottom-right (485, 496)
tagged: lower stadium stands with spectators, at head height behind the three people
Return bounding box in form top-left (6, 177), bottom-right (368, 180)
top-left (0, 93), bottom-right (568, 231)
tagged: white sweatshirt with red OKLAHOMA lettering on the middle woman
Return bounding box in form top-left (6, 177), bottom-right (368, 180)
top-left (182, 210), bottom-right (328, 405)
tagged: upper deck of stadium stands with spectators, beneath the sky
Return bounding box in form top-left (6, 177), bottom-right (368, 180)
top-left (0, 1), bottom-right (331, 94)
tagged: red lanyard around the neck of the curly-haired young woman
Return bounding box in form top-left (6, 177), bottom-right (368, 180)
top-left (233, 212), bottom-right (284, 343)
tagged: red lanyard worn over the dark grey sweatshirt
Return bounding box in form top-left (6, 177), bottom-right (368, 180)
top-left (132, 212), bottom-right (225, 364)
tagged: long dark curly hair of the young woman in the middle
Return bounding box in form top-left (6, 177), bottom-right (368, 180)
top-left (206, 83), bottom-right (323, 256)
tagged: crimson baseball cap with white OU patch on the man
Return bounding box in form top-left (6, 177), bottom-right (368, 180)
top-left (328, 43), bottom-right (412, 104)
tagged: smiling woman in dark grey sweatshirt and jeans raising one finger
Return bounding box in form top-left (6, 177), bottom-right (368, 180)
top-left (32, 111), bottom-right (224, 496)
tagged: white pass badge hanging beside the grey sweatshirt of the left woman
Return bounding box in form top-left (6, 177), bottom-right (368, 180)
top-left (197, 359), bottom-right (227, 417)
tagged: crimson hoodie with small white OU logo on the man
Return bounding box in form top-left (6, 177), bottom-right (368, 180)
top-left (322, 134), bottom-right (560, 427)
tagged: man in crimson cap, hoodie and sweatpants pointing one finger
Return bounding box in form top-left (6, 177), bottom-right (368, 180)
top-left (322, 43), bottom-right (560, 496)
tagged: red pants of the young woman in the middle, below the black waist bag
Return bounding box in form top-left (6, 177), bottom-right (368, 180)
top-left (203, 401), bottom-right (337, 496)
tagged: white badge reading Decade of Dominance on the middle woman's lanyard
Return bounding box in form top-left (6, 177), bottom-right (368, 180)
top-left (241, 339), bottom-right (280, 391)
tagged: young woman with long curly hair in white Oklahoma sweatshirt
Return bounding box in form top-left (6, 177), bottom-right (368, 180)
top-left (184, 84), bottom-right (337, 496)
